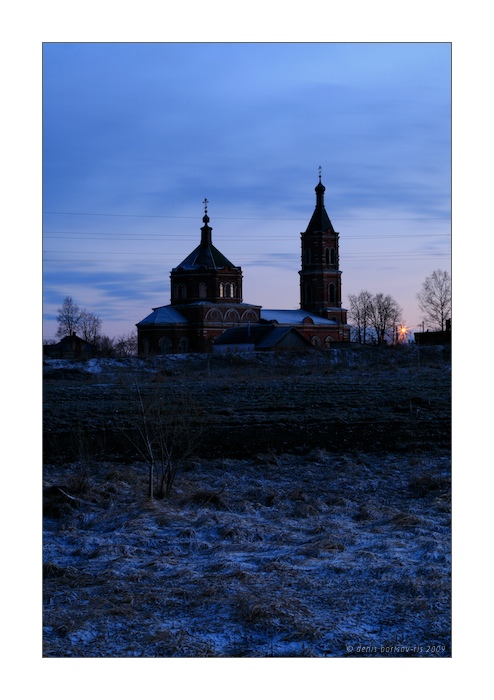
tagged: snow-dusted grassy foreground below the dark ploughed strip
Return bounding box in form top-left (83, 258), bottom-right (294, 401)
top-left (43, 450), bottom-right (451, 657)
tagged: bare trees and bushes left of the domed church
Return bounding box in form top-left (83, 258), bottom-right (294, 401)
top-left (51, 297), bottom-right (137, 357)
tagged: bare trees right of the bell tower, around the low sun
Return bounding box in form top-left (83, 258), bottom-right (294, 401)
top-left (348, 270), bottom-right (451, 345)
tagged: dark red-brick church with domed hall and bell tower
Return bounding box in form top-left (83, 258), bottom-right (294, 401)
top-left (136, 174), bottom-right (350, 357)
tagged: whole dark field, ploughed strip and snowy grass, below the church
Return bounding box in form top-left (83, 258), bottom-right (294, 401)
top-left (43, 348), bottom-right (451, 657)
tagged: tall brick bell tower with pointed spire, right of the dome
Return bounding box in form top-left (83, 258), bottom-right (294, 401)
top-left (299, 167), bottom-right (347, 324)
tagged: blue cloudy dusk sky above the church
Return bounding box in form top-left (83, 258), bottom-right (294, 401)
top-left (42, 42), bottom-right (451, 339)
